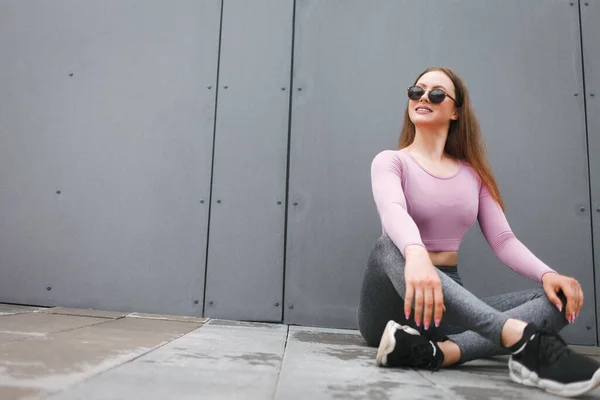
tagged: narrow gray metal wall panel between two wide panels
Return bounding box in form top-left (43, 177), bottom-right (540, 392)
top-left (205, 0), bottom-right (293, 321)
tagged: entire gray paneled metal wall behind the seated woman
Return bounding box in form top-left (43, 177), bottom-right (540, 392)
top-left (0, 0), bottom-right (600, 344)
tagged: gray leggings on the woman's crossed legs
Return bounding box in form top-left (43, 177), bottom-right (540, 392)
top-left (358, 234), bottom-right (568, 363)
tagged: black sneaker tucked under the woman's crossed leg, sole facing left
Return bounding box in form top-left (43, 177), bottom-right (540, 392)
top-left (376, 321), bottom-right (444, 371)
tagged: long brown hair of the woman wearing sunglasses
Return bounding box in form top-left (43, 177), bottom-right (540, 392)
top-left (398, 67), bottom-right (504, 209)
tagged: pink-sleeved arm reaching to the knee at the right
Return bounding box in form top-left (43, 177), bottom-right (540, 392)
top-left (477, 183), bottom-right (556, 282)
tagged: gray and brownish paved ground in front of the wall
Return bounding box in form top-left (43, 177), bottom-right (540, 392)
top-left (0, 304), bottom-right (600, 400)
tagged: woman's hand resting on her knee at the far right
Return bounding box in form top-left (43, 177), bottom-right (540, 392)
top-left (542, 272), bottom-right (583, 324)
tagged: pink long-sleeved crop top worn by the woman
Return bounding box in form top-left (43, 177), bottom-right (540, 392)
top-left (371, 150), bottom-right (554, 282)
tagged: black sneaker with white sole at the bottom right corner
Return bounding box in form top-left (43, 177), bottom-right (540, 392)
top-left (508, 329), bottom-right (600, 397)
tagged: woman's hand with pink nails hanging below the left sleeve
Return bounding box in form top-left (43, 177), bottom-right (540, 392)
top-left (404, 245), bottom-right (445, 330)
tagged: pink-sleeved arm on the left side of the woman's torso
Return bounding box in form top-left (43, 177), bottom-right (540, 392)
top-left (371, 150), bottom-right (425, 258)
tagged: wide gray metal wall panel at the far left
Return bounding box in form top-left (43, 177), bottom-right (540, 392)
top-left (0, 0), bottom-right (221, 315)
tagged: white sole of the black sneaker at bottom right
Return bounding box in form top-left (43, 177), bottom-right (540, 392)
top-left (508, 357), bottom-right (600, 397)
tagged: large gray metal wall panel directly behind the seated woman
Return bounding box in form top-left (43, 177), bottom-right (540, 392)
top-left (284, 0), bottom-right (596, 344)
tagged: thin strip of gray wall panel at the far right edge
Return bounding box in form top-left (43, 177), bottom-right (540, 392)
top-left (580, 0), bottom-right (600, 344)
